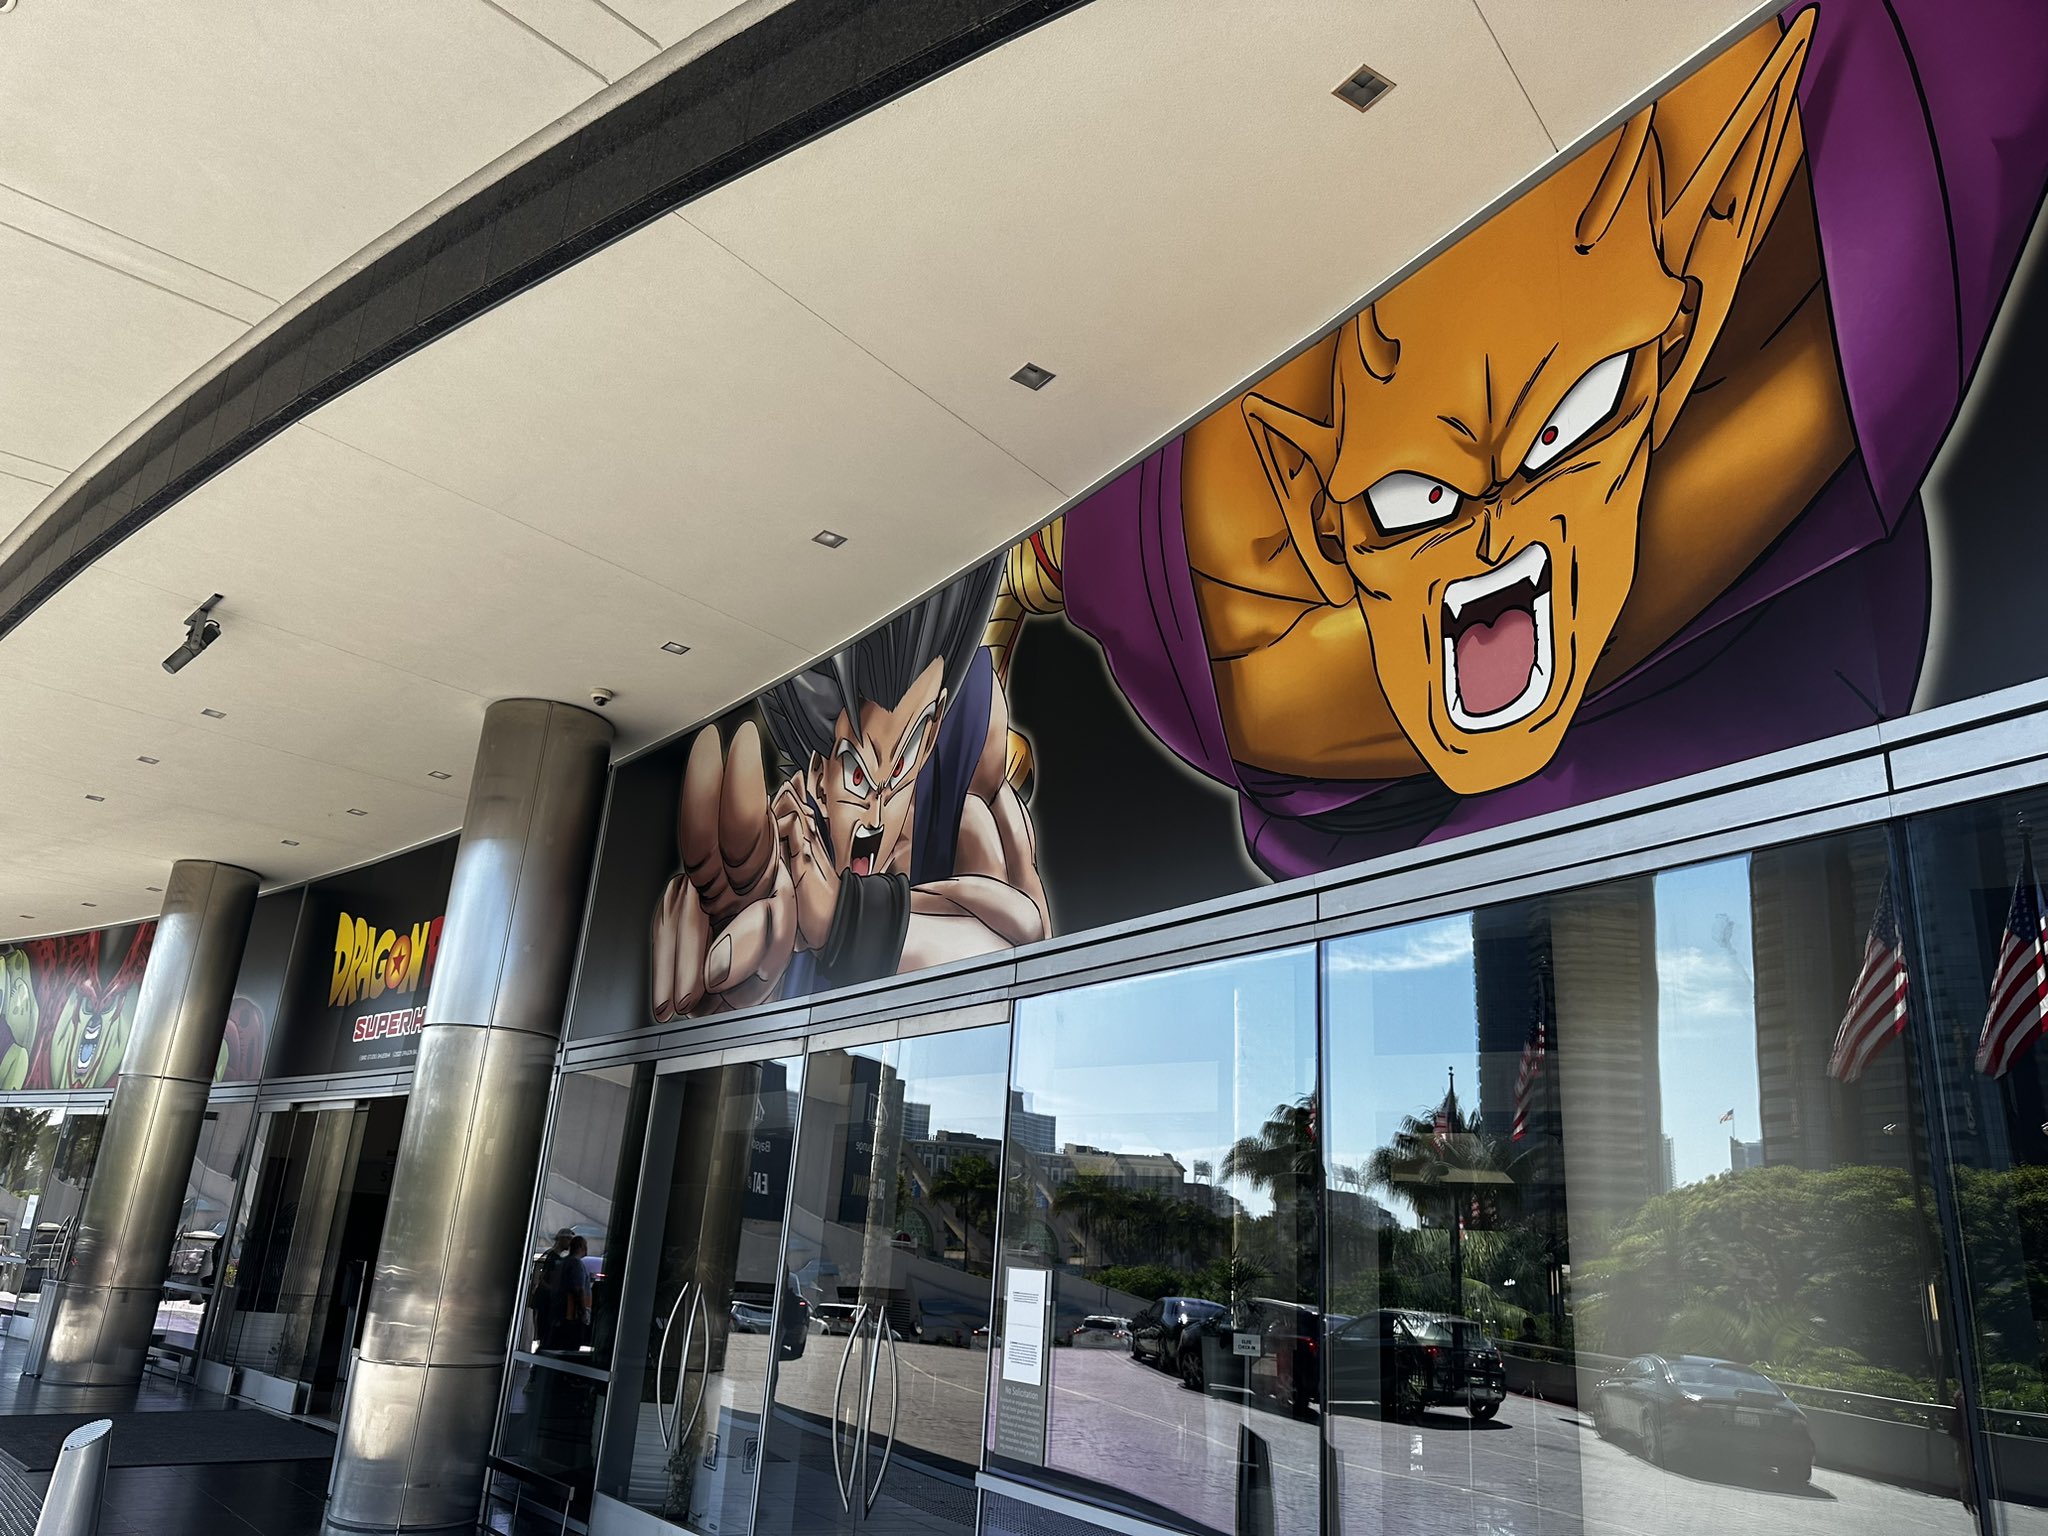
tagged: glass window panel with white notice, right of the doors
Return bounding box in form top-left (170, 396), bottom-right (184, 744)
top-left (989, 948), bottom-right (1325, 1534)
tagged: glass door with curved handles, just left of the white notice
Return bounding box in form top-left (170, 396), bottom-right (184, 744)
top-left (758, 1024), bottom-right (1010, 1536)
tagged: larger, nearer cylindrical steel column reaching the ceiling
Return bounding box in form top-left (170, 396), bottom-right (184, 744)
top-left (328, 698), bottom-right (612, 1532)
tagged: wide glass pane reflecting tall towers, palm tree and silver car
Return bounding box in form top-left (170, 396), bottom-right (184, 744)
top-left (1325, 829), bottom-right (1972, 1536)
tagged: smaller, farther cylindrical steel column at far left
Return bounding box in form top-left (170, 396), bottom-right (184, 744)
top-left (41, 858), bottom-right (256, 1386)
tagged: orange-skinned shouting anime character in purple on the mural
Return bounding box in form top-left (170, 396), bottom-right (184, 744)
top-left (1057, 0), bottom-right (2048, 877)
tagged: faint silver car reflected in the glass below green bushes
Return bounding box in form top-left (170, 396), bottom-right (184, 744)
top-left (1593, 1354), bottom-right (1812, 1487)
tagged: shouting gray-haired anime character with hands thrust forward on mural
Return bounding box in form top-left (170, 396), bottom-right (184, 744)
top-left (653, 559), bottom-right (1049, 1020)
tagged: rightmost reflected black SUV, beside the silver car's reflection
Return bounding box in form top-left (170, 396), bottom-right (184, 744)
top-left (1329, 1309), bottom-right (1507, 1419)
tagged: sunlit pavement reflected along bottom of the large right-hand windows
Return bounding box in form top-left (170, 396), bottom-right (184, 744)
top-left (1049, 1350), bottom-right (1974, 1536)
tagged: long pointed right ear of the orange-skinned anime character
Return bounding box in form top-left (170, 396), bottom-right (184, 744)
top-left (1653, 6), bottom-right (1819, 442)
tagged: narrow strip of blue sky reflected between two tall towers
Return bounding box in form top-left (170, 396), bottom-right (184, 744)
top-left (1657, 858), bottom-right (1763, 1184)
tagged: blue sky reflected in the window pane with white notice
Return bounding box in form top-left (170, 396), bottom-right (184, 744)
top-left (1007, 948), bottom-right (1315, 1212)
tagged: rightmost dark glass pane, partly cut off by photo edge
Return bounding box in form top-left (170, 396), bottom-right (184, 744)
top-left (1907, 788), bottom-right (2048, 1532)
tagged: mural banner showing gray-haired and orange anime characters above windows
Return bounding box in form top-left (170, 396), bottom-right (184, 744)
top-left (639, 0), bottom-right (2048, 1020)
